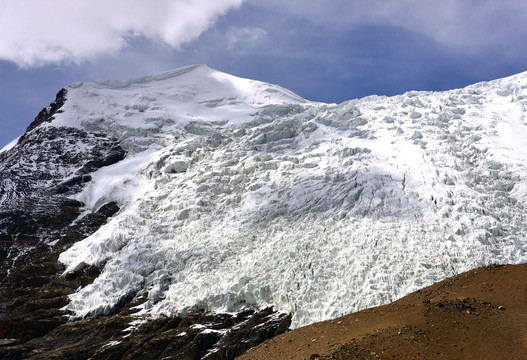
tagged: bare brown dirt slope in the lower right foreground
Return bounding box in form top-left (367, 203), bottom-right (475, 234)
top-left (239, 264), bottom-right (527, 360)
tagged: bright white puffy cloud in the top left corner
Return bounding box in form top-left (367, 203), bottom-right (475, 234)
top-left (0, 0), bottom-right (243, 68)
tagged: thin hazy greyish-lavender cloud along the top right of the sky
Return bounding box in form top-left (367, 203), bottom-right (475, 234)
top-left (252, 0), bottom-right (527, 51)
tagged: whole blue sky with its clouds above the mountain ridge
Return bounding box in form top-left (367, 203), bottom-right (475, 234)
top-left (0, 0), bottom-right (527, 148)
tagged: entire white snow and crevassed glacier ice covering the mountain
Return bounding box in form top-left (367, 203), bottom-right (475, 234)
top-left (53, 65), bottom-right (527, 327)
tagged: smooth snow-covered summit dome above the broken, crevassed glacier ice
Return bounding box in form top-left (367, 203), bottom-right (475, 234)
top-left (50, 65), bottom-right (306, 152)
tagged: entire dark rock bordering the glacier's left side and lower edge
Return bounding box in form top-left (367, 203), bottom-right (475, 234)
top-left (0, 89), bottom-right (291, 360)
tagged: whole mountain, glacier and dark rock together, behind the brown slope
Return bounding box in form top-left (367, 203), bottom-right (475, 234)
top-left (0, 65), bottom-right (527, 359)
